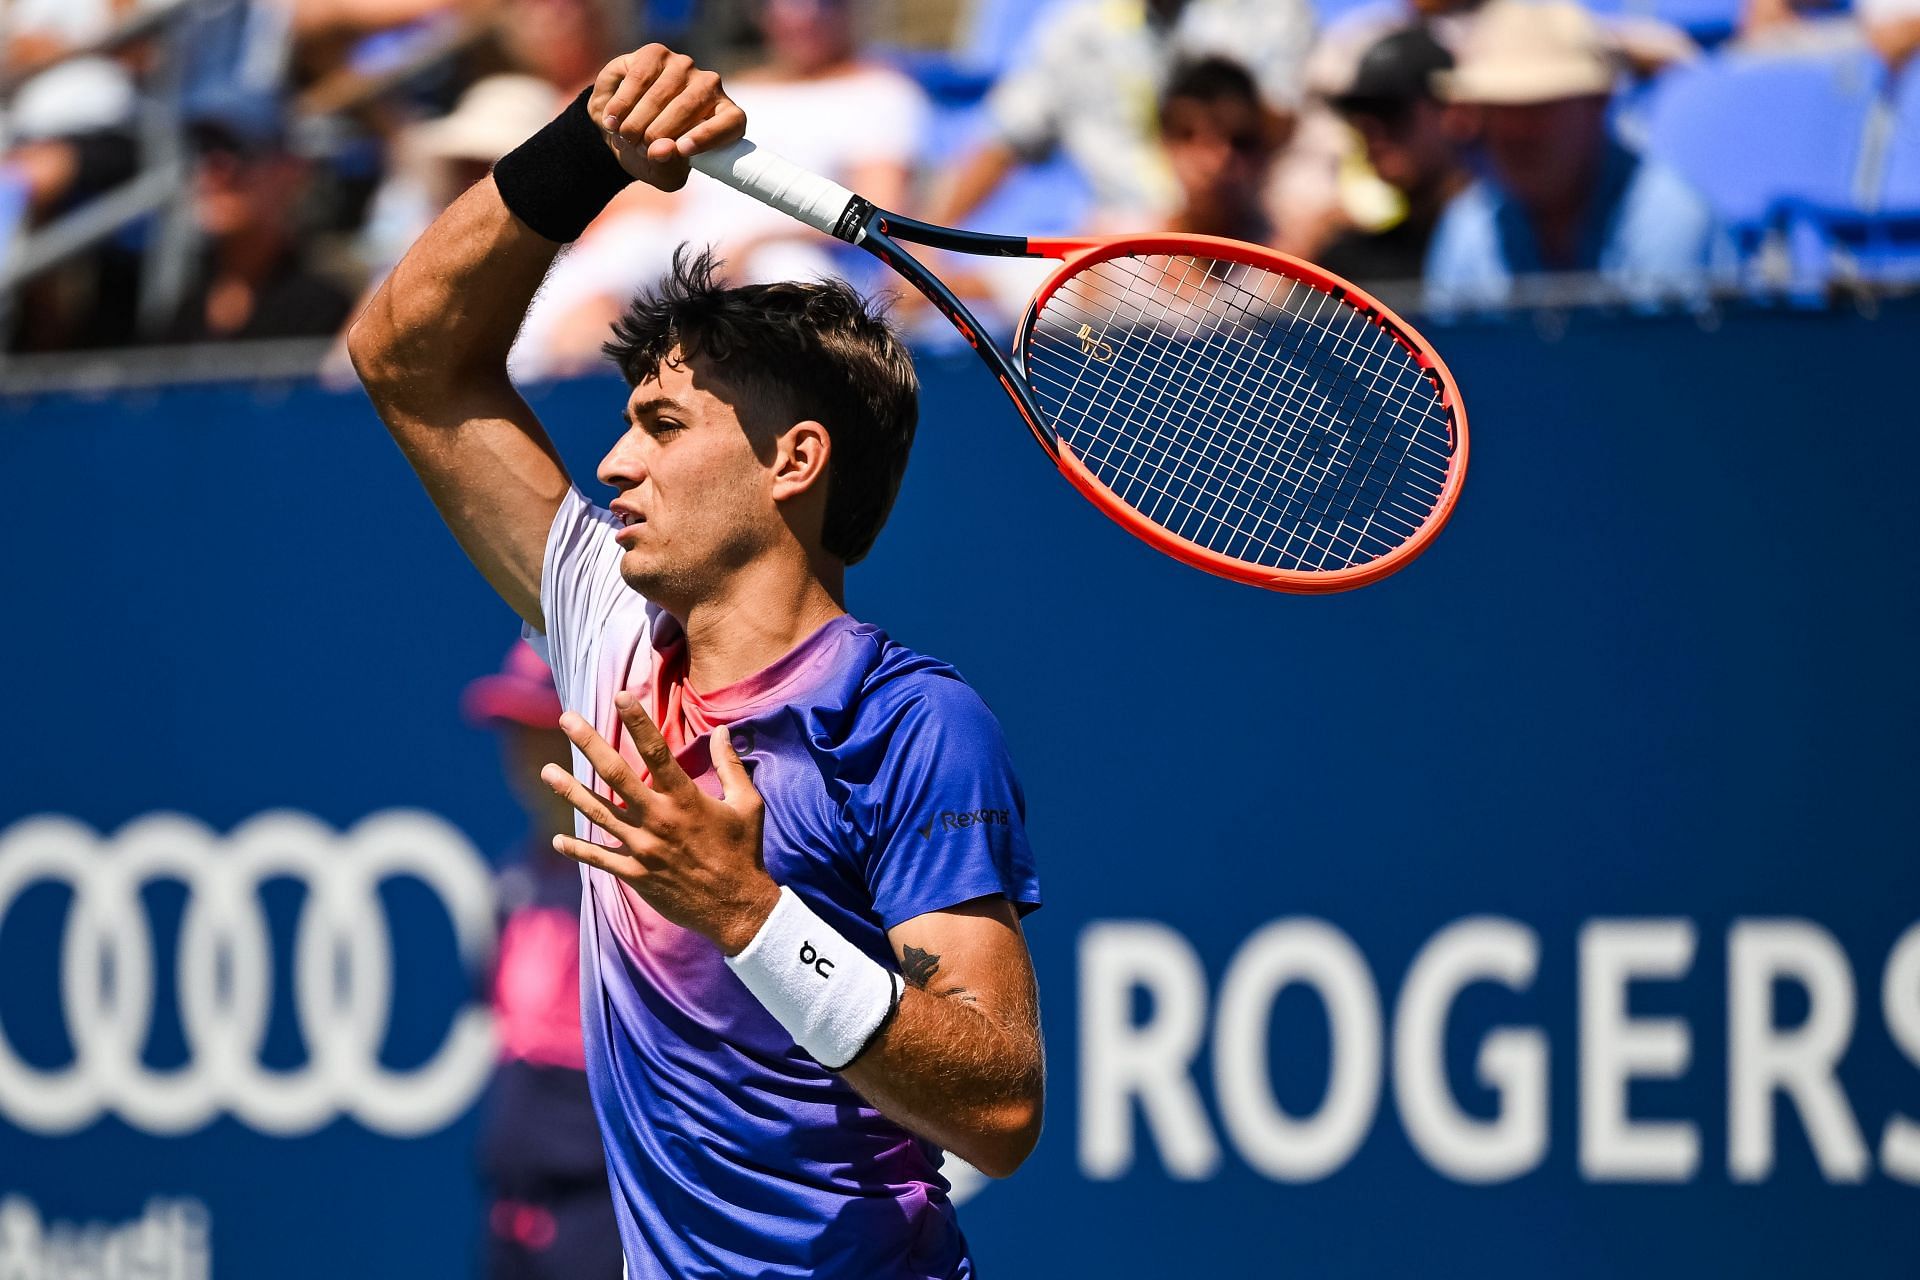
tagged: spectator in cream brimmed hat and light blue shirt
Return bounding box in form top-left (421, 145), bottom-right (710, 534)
top-left (1427, 0), bottom-right (1726, 305)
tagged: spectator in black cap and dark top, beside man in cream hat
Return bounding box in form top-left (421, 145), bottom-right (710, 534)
top-left (1319, 27), bottom-right (1469, 282)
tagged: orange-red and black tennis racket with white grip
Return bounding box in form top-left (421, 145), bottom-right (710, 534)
top-left (691, 140), bottom-right (1467, 593)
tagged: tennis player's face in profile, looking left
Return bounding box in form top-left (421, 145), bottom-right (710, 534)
top-left (599, 351), bottom-right (785, 616)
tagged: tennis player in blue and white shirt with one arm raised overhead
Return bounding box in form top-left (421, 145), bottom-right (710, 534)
top-left (349, 44), bottom-right (1043, 1278)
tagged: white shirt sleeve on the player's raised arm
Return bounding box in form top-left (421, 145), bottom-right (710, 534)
top-left (520, 487), bottom-right (632, 710)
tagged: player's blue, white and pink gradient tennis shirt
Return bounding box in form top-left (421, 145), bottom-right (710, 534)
top-left (530, 491), bottom-right (1041, 1280)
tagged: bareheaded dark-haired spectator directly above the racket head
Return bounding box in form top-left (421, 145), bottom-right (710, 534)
top-left (1160, 58), bottom-right (1279, 244)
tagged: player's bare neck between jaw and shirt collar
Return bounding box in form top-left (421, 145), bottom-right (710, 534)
top-left (680, 557), bottom-right (847, 693)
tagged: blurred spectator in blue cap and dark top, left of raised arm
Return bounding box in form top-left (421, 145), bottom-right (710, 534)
top-left (161, 102), bottom-right (353, 342)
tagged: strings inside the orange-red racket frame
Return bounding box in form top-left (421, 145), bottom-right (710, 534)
top-left (1027, 255), bottom-right (1453, 572)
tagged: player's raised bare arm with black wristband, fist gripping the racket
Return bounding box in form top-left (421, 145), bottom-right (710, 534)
top-left (348, 44), bottom-right (747, 629)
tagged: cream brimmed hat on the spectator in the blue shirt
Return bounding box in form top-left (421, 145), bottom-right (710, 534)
top-left (1434, 0), bottom-right (1617, 106)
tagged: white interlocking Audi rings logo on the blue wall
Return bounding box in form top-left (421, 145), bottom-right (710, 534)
top-left (0, 810), bottom-right (493, 1136)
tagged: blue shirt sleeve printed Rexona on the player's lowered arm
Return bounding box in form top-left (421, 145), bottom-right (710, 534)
top-left (852, 677), bottom-right (1041, 929)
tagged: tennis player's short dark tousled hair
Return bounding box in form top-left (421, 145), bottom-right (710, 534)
top-left (605, 246), bottom-right (920, 564)
